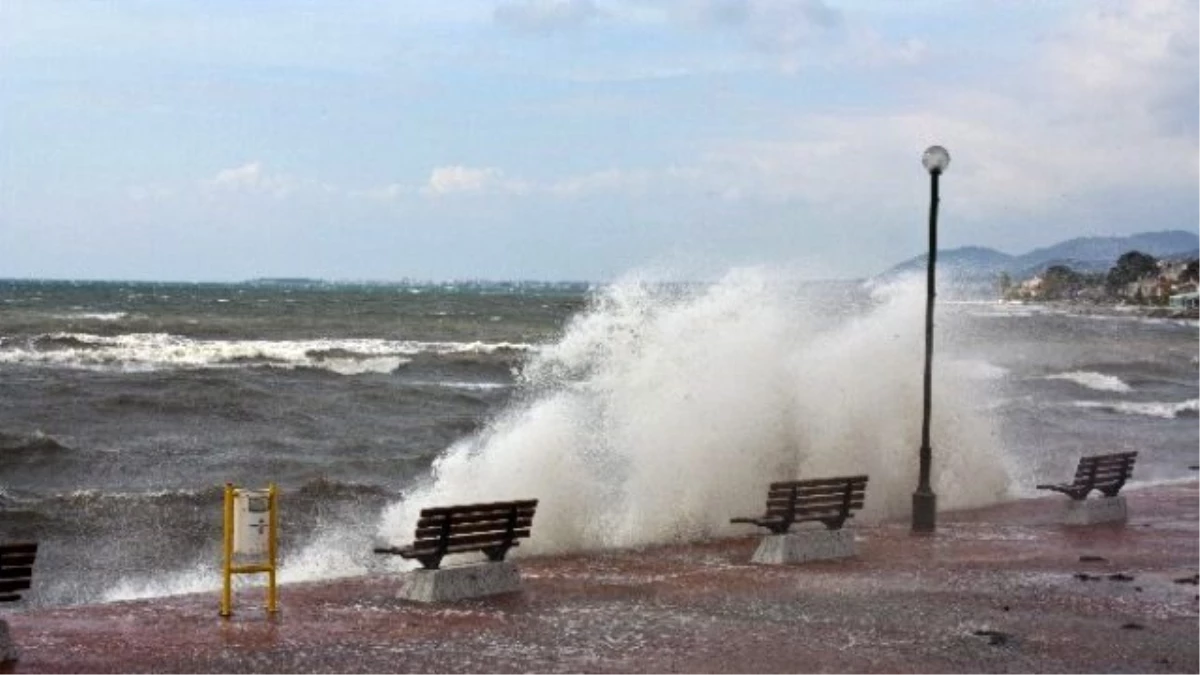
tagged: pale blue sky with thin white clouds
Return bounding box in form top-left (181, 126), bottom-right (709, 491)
top-left (0, 0), bottom-right (1200, 281)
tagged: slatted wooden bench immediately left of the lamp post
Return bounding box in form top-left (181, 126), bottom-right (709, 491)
top-left (730, 476), bottom-right (866, 534)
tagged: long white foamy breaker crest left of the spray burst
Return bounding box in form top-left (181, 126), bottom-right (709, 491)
top-left (0, 333), bottom-right (533, 375)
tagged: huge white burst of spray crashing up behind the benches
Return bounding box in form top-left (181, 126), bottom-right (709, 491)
top-left (379, 269), bottom-right (1008, 551)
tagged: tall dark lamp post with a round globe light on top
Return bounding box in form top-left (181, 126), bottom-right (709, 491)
top-left (912, 145), bottom-right (950, 532)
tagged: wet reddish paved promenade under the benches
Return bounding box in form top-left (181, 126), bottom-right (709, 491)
top-left (0, 482), bottom-right (1200, 675)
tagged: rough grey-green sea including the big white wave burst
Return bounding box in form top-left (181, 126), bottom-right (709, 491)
top-left (0, 267), bottom-right (1200, 607)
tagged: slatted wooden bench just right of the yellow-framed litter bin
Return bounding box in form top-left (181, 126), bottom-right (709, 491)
top-left (374, 500), bottom-right (538, 569)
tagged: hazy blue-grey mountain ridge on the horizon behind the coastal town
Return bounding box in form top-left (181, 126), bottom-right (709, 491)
top-left (881, 229), bottom-right (1200, 280)
